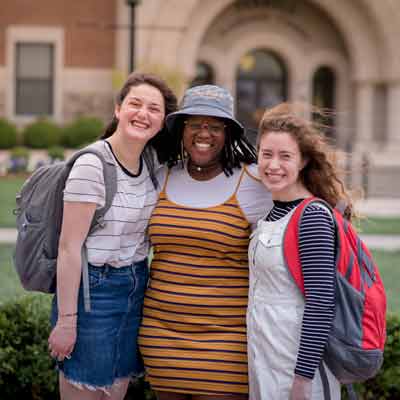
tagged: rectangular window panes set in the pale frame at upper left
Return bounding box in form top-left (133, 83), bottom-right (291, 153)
top-left (15, 42), bottom-right (54, 115)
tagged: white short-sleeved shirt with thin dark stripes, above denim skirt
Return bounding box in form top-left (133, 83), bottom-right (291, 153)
top-left (64, 141), bottom-right (158, 267)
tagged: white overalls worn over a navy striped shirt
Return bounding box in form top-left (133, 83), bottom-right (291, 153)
top-left (247, 210), bottom-right (340, 400)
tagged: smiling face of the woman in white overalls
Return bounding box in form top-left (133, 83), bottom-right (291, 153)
top-left (258, 132), bottom-right (309, 201)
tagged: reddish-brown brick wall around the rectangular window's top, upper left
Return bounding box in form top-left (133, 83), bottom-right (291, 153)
top-left (0, 0), bottom-right (116, 68)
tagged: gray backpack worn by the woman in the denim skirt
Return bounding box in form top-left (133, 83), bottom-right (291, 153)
top-left (14, 141), bottom-right (117, 310)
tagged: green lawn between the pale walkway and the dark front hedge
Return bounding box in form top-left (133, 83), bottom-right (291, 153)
top-left (0, 245), bottom-right (400, 316)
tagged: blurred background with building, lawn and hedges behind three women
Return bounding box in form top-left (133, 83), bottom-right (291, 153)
top-left (0, 0), bottom-right (400, 400)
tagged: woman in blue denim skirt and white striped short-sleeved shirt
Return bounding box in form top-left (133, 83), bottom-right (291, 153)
top-left (49, 73), bottom-right (177, 400)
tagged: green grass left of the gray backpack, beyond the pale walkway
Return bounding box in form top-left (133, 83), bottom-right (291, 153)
top-left (0, 176), bottom-right (27, 228)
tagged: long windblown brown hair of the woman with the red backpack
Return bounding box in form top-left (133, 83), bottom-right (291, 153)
top-left (257, 103), bottom-right (353, 219)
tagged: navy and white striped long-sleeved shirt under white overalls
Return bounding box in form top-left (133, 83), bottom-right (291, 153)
top-left (266, 199), bottom-right (335, 379)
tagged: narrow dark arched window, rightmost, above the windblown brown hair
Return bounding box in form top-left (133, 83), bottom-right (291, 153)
top-left (313, 66), bottom-right (336, 138)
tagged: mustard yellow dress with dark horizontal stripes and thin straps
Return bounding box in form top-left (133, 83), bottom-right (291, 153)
top-left (139, 170), bottom-right (250, 395)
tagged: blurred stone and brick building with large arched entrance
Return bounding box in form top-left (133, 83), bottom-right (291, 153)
top-left (0, 0), bottom-right (400, 197)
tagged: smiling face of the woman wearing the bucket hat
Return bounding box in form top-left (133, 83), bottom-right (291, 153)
top-left (183, 116), bottom-right (225, 167)
